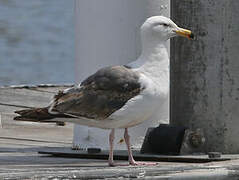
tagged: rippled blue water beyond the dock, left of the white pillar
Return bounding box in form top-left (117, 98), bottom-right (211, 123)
top-left (0, 0), bottom-right (75, 86)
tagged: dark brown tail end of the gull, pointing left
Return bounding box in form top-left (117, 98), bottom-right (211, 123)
top-left (14, 107), bottom-right (72, 123)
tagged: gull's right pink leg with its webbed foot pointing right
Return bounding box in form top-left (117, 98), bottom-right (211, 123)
top-left (124, 128), bottom-right (157, 166)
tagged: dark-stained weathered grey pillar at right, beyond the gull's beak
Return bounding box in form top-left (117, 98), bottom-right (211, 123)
top-left (170, 0), bottom-right (239, 153)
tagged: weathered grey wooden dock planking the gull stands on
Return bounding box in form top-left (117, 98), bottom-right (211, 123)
top-left (0, 87), bottom-right (239, 180)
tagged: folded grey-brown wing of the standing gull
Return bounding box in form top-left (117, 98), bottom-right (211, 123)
top-left (51, 66), bottom-right (143, 120)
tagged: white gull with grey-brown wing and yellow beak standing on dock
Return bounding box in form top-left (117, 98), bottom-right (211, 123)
top-left (14, 16), bottom-right (194, 166)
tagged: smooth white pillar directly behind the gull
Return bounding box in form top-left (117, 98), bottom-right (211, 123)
top-left (73, 0), bottom-right (169, 149)
